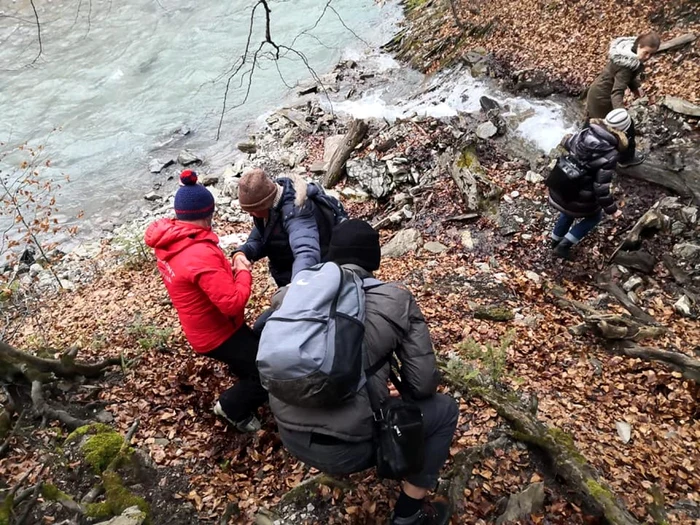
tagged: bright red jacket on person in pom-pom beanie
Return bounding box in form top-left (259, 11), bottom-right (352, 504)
top-left (145, 219), bottom-right (252, 354)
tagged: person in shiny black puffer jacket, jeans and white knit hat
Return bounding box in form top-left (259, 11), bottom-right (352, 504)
top-left (545, 109), bottom-right (632, 259)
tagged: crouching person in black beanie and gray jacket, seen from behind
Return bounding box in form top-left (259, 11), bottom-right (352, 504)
top-left (258, 219), bottom-right (459, 525)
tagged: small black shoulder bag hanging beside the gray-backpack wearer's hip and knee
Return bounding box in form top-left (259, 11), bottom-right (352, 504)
top-left (367, 355), bottom-right (425, 479)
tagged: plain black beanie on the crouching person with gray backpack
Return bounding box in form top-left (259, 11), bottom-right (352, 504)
top-left (327, 219), bottom-right (382, 272)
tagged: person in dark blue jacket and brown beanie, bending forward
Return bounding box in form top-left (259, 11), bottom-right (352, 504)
top-left (234, 169), bottom-right (347, 288)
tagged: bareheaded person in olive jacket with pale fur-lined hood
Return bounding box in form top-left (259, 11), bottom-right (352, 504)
top-left (586, 33), bottom-right (661, 167)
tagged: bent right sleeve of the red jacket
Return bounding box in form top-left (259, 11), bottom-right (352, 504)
top-left (194, 249), bottom-right (253, 317)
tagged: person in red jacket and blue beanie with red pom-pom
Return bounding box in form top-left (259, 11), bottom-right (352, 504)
top-left (145, 170), bottom-right (267, 432)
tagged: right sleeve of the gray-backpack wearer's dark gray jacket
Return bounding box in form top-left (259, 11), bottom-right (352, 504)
top-left (396, 294), bottom-right (440, 399)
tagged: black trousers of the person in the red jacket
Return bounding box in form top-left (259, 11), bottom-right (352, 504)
top-left (205, 325), bottom-right (267, 422)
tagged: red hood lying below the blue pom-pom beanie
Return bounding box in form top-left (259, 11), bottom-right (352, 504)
top-left (144, 219), bottom-right (219, 261)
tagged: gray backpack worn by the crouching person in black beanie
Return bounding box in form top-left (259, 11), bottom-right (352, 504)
top-left (257, 262), bottom-right (381, 408)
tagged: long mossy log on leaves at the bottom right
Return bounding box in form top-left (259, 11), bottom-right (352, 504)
top-left (441, 359), bottom-right (640, 525)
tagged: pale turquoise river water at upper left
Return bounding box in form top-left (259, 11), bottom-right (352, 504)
top-left (0, 0), bottom-right (400, 217)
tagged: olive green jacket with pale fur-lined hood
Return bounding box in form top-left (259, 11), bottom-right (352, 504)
top-left (586, 37), bottom-right (644, 119)
